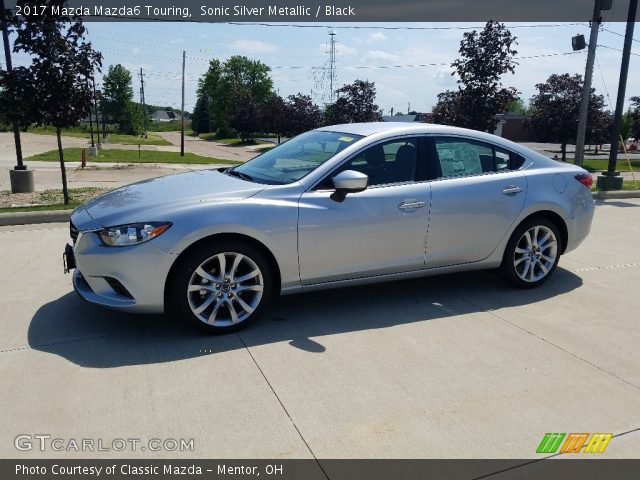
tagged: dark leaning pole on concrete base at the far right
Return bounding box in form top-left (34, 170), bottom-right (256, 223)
top-left (596, 0), bottom-right (638, 190)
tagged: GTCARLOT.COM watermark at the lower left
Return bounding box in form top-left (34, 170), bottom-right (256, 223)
top-left (13, 433), bottom-right (195, 452)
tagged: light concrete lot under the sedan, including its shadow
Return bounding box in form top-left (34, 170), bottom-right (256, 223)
top-left (0, 200), bottom-right (640, 459)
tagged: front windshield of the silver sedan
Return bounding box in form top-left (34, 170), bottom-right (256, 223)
top-left (227, 130), bottom-right (362, 185)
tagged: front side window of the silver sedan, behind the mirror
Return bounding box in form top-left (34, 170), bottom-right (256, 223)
top-left (322, 138), bottom-right (418, 188)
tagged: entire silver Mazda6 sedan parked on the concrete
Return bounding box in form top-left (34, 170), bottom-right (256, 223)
top-left (65, 123), bottom-right (594, 332)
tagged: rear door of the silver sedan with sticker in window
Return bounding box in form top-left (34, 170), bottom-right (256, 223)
top-left (427, 136), bottom-right (527, 268)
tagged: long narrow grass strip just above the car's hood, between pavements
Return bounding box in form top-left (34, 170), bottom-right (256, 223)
top-left (26, 148), bottom-right (238, 165)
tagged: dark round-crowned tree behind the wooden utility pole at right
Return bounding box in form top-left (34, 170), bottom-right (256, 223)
top-left (527, 73), bottom-right (611, 161)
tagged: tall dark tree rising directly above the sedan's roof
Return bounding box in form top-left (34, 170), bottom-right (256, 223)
top-left (433, 21), bottom-right (518, 132)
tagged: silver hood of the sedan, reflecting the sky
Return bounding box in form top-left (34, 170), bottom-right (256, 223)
top-left (78, 170), bottom-right (265, 229)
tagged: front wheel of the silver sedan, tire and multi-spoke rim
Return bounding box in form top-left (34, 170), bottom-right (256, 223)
top-left (167, 241), bottom-right (273, 334)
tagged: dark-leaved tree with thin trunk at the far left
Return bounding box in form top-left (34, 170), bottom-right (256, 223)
top-left (1, 0), bottom-right (102, 204)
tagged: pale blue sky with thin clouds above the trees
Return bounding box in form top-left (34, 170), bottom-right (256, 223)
top-left (14, 20), bottom-right (640, 114)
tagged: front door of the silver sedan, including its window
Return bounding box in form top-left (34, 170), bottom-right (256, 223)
top-left (298, 138), bottom-right (430, 285)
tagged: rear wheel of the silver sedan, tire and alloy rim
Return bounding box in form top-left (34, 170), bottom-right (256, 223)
top-left (500, 217), bottom-right (562, 288)
